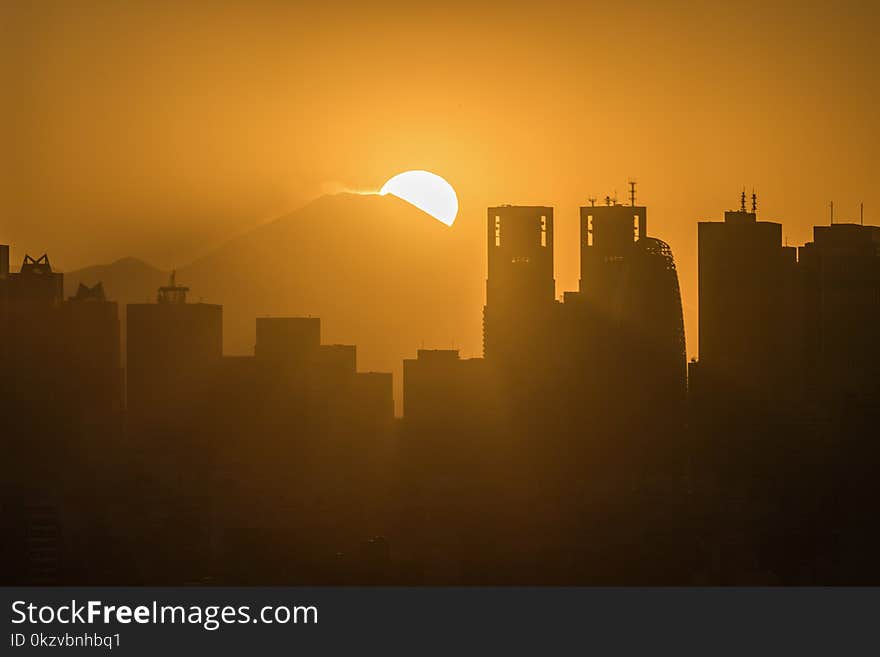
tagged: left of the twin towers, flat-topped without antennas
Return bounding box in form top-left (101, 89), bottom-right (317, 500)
top-left (483, 205), bottom-right (556, 360)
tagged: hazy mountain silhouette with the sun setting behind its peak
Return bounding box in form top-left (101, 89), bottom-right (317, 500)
top-left (66, 194), bottom-right (485, 412)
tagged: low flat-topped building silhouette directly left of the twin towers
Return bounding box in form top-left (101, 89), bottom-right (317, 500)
top-left (399, 349), bottom-right (502, 584)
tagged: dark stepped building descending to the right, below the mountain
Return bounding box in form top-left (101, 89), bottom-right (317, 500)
top-left (213, 317), bottom-right (394, 584)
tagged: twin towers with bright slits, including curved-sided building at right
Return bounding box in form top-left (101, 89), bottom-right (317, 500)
top-left (483, 192), bottom-right (686, 435)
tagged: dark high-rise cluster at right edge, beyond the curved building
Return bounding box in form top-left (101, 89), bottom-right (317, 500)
top-left (689, 194), bottom-right (880, 584)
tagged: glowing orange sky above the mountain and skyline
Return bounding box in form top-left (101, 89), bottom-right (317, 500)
top-left (0, 0), bottom-right (880, 355)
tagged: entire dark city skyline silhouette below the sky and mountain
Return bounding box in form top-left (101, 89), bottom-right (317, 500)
top-left (0, 194), bottom-right (880, 584)
